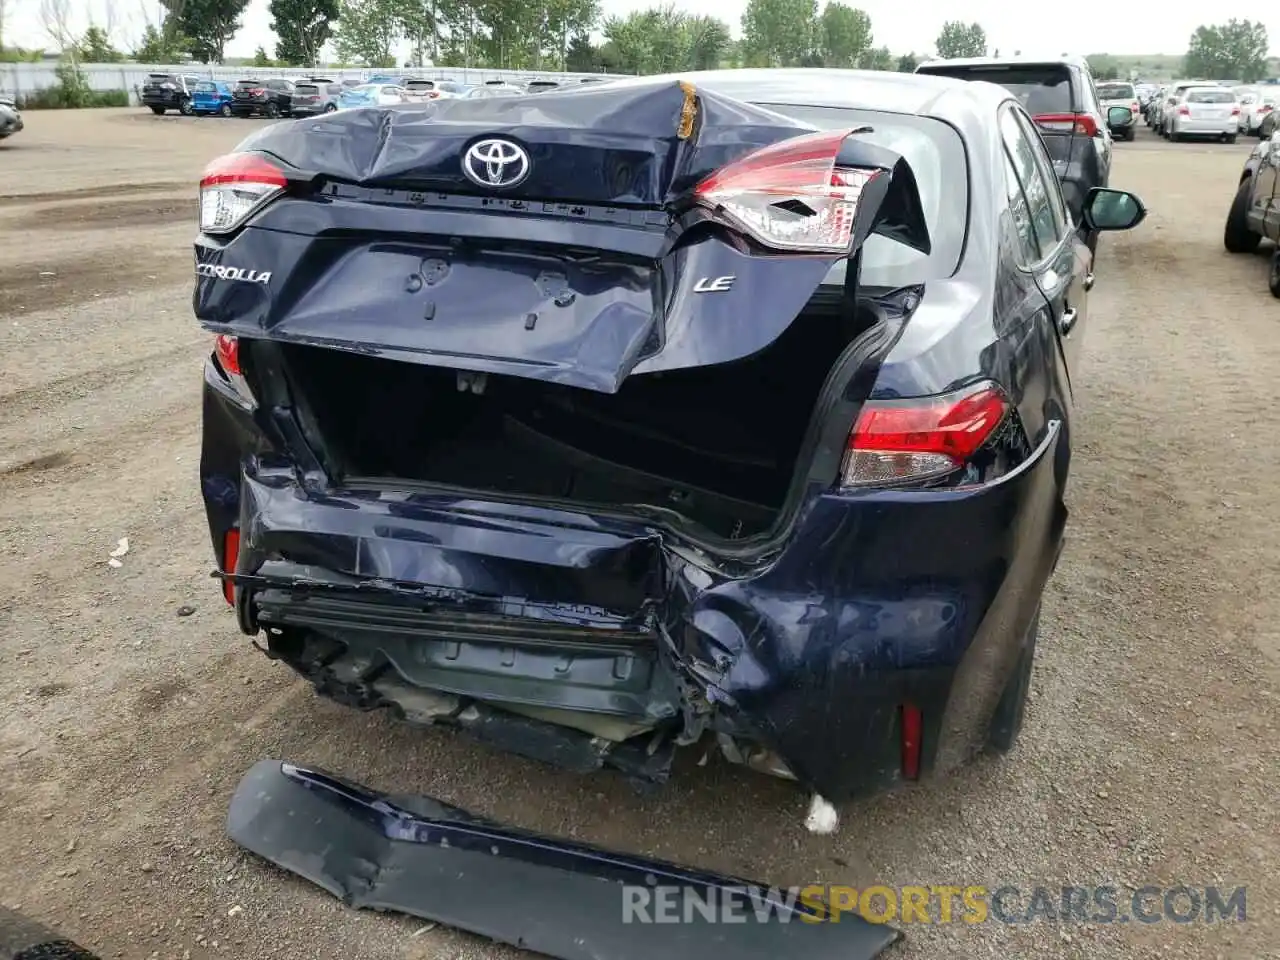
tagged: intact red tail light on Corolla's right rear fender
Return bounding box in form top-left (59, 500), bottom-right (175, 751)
top-left (841, 383), bottom-right (1010, 488)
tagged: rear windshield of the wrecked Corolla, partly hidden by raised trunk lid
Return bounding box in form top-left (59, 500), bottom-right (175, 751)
top-left (759, 102), bottom-right (969, 287)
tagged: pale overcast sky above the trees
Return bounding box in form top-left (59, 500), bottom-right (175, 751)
top-left (4, 0), bottom-right (1280, 56)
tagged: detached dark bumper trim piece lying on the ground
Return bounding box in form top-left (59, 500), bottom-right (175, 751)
top-left (227, 760), bottom-right (901, 960)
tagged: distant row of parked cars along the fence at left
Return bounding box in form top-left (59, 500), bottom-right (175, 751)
top-left (140, 73), bottom-right (602, 118)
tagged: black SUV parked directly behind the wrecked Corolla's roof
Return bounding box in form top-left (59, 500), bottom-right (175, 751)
top-left (915, 56), bottom-right (1111, 250)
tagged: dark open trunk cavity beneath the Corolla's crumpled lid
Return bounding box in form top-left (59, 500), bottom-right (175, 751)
top-left (284, 288), bottom-right (883, 539)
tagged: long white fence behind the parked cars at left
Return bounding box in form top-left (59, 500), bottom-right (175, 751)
top-left (0, 61), bottom-right (629, 104)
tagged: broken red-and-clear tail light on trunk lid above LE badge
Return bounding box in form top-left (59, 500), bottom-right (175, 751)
top-left (694, 131), bottom-right (879, 253)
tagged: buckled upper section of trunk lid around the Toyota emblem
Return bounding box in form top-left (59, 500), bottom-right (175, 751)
top-left (241, 81), bottom-right (812, 206)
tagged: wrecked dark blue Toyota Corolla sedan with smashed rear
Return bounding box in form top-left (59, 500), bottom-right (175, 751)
top-left (195, 70), bottom-right (1144, 800)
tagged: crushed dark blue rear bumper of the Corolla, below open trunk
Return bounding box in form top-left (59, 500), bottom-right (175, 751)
top-left (201, 358), bottom-right (1066, 803)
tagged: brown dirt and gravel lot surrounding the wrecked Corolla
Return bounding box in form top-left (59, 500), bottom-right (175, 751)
top-left (0, 110), bottom-right (1280, 960)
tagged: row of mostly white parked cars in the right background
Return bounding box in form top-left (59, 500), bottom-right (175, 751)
top-left (1138, 79), bottom-right (1280, 143)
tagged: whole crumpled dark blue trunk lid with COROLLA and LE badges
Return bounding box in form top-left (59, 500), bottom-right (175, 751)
top-left (195, 81), bottom-right (928, 392)
